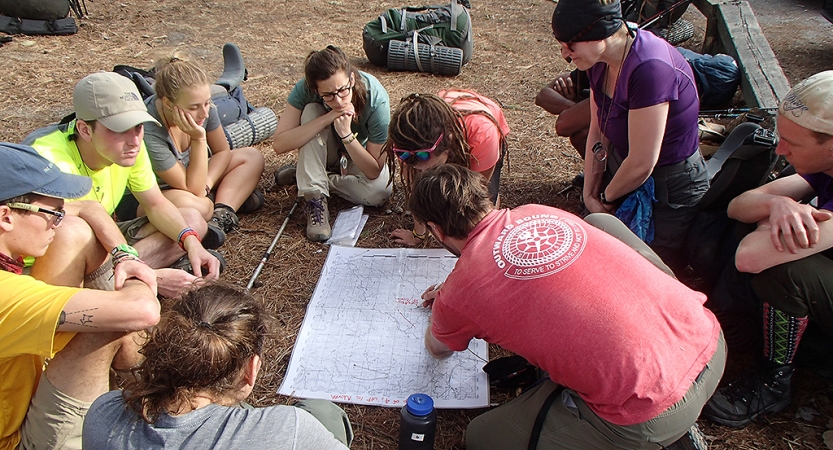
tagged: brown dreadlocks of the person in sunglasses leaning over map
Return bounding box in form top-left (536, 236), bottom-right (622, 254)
top-left (382, 94), bottom-right (471, 198)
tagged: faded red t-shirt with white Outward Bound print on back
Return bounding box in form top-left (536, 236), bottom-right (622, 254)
top-left (432, 205), bottom-right (720, 425)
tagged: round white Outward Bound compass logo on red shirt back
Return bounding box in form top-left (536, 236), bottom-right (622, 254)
top-left (492, 214), bottom-right (587, 279)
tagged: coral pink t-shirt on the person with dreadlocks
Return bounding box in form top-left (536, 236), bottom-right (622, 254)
top-left (437, 90), bottom-right (509, 172)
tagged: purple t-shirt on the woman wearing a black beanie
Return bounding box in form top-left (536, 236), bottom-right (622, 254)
top-left (587, 30), bottom-right (700, 167)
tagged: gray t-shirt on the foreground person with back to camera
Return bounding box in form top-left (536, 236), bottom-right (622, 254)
top-left (82, 391), bottom-right (347, 450)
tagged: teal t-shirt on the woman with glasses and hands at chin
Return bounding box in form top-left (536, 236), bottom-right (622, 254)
top-left (286, 71), bottom-right (390, 146)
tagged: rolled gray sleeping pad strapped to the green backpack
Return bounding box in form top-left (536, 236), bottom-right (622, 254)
top-left (388, 41), bottom-right (463, 75)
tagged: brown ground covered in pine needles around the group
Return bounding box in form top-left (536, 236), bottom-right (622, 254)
top-left (0, 0), bottom-right (833, 449)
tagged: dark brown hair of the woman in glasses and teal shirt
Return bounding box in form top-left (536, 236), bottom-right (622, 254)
top-left (304, 45), bottom-right (367, 116)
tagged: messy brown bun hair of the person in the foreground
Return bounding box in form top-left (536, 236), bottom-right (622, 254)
top-left (123, 283), bottom-right (269, 423)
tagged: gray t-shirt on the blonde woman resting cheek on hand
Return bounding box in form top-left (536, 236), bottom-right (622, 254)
top-left (144, 94), bottom-right (221, 189)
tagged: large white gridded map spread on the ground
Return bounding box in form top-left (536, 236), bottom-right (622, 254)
top-left (278, 246), bottom-right (489, 408)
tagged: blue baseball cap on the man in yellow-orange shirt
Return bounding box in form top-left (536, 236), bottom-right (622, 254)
top-left (0, 142), bottom-right (92, 200)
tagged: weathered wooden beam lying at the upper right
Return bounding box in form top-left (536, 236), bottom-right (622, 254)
top-left (716, 1), bottom-right (790, 108)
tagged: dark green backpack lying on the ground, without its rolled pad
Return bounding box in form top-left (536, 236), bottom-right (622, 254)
top-left (362, 0), bottom-right (473, 67)
